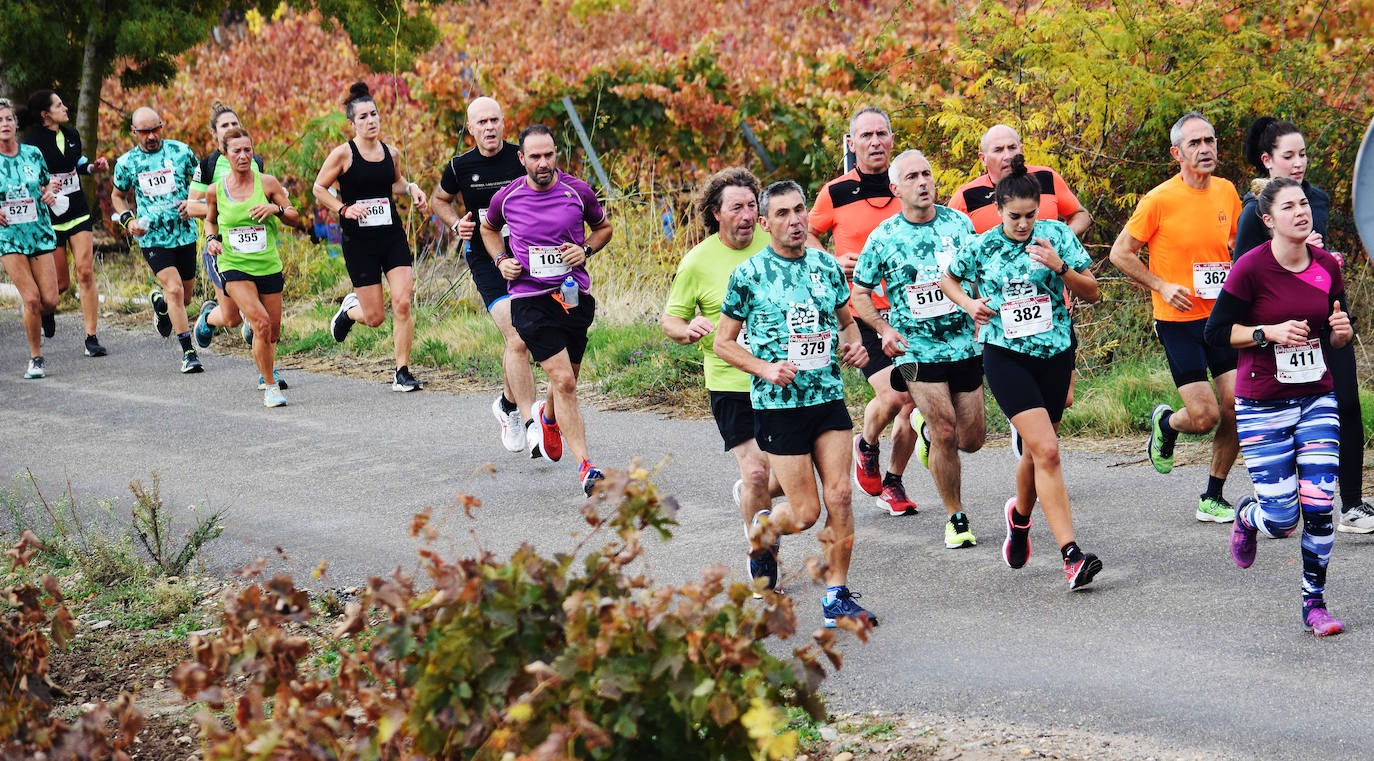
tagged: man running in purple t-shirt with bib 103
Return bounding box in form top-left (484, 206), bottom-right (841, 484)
top-left (481, 124), bottom-right (611, 496)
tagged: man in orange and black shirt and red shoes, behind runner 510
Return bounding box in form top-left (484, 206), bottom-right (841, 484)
top-left (807, 106), bottom-right (916, 515)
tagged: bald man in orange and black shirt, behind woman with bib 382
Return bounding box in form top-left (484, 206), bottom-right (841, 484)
top-left (949, 124), bottom-right (1092, 238)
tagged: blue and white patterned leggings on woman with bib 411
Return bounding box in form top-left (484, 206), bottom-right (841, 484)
top-left (1235, 394), bottom-right (1341, 600)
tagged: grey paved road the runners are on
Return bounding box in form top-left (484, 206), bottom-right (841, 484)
top-left (0, 310), bottom-right (1374, 760)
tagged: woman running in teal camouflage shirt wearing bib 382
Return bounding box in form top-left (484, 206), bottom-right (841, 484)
top-left (940, 157), bottom-right (1102, 589)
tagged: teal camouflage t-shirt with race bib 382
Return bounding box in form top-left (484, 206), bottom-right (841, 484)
top-left (949, 220), bottom-right (1092, 357)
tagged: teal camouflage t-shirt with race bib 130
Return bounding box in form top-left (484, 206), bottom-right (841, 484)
top-left (114, 140), bottom-right (196, 249)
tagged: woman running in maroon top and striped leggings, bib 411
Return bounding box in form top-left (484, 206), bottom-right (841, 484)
top-left (1206, 177), bottom-right (1355, 637)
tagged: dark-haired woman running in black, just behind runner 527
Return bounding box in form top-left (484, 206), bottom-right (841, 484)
top-left (19, 89), bottom-right (110, 357)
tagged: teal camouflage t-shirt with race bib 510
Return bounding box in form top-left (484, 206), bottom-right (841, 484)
top-left (853, 206), bottom-right (980, 364)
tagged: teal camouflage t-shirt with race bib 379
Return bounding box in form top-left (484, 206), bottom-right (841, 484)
top-left (720, 246), bottom-right (849, 409)
